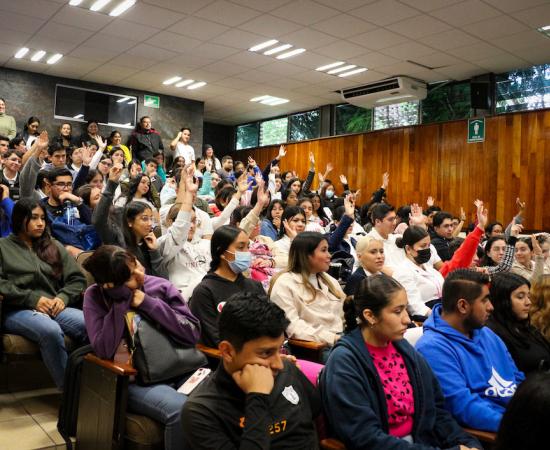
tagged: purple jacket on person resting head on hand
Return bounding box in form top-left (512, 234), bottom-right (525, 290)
top-left (83, 275), bottom-right (201, 359)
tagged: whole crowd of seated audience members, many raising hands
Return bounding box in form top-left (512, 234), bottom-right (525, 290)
top-left (0, 99), bottom-right (550, 450)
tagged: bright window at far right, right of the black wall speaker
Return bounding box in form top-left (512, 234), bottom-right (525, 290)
top-left (496, 64), bottom-right (550, 113)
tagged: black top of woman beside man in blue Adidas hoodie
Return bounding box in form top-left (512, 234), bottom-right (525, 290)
top-left (487, 317), bottom-right (550, 375)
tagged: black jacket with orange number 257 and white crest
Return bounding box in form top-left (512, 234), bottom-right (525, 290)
top-left (181, 362), bottom-right (320, 450)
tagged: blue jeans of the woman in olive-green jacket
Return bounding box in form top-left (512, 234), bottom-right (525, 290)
top-left (4, 308), bottom-right (88, 389)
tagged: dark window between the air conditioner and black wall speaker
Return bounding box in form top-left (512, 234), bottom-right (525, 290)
top-left (422, 82), bottom-right (470, 123)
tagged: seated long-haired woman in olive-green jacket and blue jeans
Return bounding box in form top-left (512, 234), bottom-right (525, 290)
top-left (0, 198), bottom-right (87, 389)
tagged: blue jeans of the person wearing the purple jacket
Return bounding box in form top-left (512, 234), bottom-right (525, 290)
top-left (128, 377), bottom-right (187, 450)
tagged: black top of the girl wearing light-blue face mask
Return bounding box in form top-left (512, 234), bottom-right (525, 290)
top-left (189, 272), bottom-right (265, 347)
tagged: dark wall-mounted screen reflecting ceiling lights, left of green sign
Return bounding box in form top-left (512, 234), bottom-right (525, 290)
top-left (54, 84), bottom-right (137, 128)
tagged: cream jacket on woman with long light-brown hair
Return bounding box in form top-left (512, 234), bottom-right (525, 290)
top-left (270, 272), bottom-right (345, 345)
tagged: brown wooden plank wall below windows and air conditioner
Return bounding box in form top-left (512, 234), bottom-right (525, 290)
top-left (232, 110), bottom-right (550, 230)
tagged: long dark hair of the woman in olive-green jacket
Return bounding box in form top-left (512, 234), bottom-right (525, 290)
top-left (11, 198), bottom-right (63, 279)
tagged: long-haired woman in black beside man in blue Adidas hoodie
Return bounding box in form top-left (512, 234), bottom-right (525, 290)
top-left (487, 273), bottom-right (550, 375)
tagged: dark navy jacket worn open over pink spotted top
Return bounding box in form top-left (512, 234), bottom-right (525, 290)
top-left (320, 328), bottom-right (482, 450)
